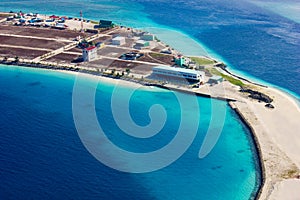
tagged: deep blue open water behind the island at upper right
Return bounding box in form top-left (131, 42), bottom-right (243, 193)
top-left (137, 0), bottom-right (300, 95)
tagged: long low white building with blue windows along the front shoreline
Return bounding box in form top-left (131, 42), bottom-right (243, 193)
top-left (152, 66), bottom-right (205, 83)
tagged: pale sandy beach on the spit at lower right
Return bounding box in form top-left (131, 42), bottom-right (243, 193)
top-left (232, 85), bottom-right (300, 199)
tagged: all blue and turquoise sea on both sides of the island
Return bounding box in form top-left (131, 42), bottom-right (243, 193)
top-left (0, 0), bottom-right (300, 199)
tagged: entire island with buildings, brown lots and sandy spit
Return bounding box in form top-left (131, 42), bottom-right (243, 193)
top-left (0, 11), bottom-right (300, 199)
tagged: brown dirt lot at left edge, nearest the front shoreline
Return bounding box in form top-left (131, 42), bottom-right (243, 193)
top-left (0, 47), bottom-right (47, 59)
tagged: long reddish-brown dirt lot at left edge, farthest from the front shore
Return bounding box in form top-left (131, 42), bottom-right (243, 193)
top-left (0, 25), bottom-right (93, 40)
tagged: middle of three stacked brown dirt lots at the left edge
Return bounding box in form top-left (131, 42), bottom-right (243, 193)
top-left (0, 35), bottom-right (68, 50)
